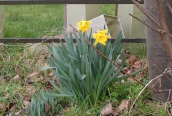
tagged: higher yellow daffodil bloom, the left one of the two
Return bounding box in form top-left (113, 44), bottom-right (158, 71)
top-left (77, 20), bottom-right (91, 33)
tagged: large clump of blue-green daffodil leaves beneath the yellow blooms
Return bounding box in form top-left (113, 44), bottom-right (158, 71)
top-left (43, 28), bottom-right (135, 104)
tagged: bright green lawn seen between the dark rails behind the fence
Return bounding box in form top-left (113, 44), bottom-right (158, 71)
top-left (4, 5), bottom-right (115, 38)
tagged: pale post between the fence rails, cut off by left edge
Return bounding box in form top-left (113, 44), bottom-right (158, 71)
top-left (0, 5), bottom-right (4, 38)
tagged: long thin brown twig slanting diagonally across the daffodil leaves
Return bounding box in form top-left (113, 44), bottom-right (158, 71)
top-left (69, 24), bottom-right (157, 92)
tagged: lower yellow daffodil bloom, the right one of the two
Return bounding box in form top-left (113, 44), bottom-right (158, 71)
top-left (93, 30), bottom-right (111, 46)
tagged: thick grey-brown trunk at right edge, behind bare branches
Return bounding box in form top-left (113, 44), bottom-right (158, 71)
top-left (145, 0), bottom-right (172, 102)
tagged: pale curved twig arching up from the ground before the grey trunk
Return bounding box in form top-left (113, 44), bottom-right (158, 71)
top-left (129, 71), bottom-right (171, 114)
